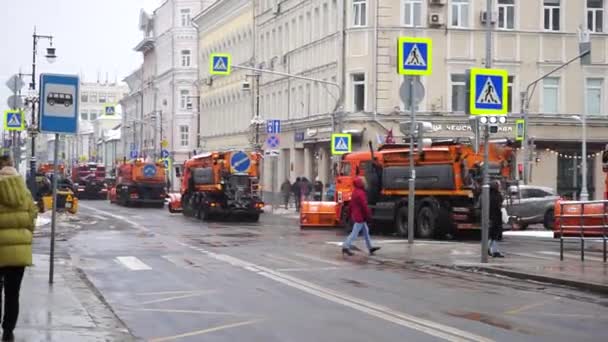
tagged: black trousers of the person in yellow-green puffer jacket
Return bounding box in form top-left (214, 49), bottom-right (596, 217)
top-left (0, 267), bottom-right (25, 332)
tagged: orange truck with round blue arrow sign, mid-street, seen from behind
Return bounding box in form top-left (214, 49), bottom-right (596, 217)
top-left (169, 151), bottom-right (264, 222)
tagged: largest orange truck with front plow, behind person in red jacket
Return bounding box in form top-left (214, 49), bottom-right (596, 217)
top-left (300, 140), bottom-right (514, 238)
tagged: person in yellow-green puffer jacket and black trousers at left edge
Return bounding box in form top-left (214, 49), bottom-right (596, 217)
top-left (0, 157), bottom-right (38, 341)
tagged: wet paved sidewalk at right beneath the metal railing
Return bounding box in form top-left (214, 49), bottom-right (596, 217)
top-left (330, 237), bottom-right (608, 294)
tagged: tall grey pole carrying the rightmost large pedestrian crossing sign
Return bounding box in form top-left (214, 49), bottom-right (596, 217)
top-left (477, 0), bottom-right (493, 263)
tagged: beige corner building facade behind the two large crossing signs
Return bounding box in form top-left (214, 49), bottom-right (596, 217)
top-left (199, 0), bottom-right (608, 198)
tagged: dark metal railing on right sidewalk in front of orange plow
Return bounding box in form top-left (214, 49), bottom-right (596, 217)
top-left (556, 201), bottom-right (608, 262)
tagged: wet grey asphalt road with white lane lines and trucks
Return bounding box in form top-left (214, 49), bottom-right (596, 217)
top-left (61, 201), bottom-right (608, 342)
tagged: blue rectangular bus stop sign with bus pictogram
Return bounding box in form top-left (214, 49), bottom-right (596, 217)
top-left (39, 74), bottom-right (80, 134)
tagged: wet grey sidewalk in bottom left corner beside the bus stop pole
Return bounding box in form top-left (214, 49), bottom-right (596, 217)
top-left (15, 254), bottom-right (134, 342)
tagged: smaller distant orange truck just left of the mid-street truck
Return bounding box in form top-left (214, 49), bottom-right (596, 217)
top-left (110, 159), bottom-right (167, 208)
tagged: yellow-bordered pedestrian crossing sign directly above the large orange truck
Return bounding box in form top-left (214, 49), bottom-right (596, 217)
top-left (397, 37), bottom-right (433, 75)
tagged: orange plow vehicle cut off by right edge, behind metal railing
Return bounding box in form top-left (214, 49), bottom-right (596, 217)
top-left (553, 146), bottom-right (608, 238)
